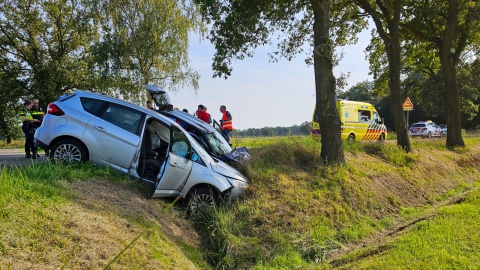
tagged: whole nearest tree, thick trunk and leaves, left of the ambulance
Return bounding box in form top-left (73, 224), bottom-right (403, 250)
top-left (195, 0), bottom-right (365, 164)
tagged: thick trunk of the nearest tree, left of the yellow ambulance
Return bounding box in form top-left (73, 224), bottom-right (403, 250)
top-left (311, 0), bottom-right (345, 164)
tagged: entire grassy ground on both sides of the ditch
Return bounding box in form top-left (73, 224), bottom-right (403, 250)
top-left (0, 135), bottom-right (480, 269)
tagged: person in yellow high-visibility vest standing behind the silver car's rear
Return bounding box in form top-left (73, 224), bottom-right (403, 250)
top-left (18, 99), bottom-right (40, 159)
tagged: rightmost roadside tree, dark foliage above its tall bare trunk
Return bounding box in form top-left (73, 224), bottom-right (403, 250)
top-left (405, 0), bottom-right (480, 148)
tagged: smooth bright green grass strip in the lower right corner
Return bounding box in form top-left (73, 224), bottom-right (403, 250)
top-left (343, 184), bottom-right (480, 269)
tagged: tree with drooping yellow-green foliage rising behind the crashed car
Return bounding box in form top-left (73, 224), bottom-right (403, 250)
top-left (94, 0), bottom-right (203, 99)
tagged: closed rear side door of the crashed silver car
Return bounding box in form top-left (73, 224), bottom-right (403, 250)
top-left (83, 103), bottom-right (144, 172)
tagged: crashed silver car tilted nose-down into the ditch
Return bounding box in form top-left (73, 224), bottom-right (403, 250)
top-left (35, 91), bottom-right (248, 209)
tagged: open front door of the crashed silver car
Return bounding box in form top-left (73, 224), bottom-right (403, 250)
top-left (156, 126), bottom-right (193, 193)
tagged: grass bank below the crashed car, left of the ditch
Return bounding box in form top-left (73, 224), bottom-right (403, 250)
top-left (0, 164), bottom-right (206, 269)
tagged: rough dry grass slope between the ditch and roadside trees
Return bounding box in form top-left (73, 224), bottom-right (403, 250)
top-left (202, 134), bottom-right (480, 269)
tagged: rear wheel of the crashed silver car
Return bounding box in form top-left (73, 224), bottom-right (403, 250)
top-left (50, 139), bottom-right (88, 162)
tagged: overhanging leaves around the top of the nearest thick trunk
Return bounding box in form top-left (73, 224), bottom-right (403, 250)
top-left (195, 0), bottom-right (366, 78)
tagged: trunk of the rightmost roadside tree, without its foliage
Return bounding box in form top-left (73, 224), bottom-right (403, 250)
top-left (440, 44), bottom-right (465, 148)
